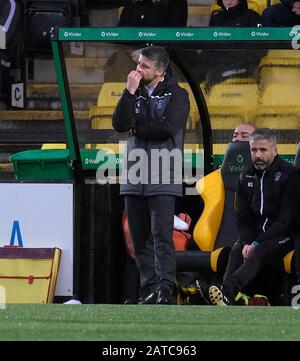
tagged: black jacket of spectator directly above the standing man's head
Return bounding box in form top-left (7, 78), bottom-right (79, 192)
top-left (119, 0), bottom-right (188, 27)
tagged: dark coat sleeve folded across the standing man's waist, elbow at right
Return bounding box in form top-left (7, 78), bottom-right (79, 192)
top-left (133, 88), bottom-right (190, 140)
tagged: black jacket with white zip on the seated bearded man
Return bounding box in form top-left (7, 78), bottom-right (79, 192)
top-left (238, 155), bottom-right (300, 243)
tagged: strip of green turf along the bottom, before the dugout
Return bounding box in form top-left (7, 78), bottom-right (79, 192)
top-left (0, 304), bottom-right (300, 341)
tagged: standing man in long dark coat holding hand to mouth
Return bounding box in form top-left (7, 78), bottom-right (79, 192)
top-left (113, 46), bottom-right (189, 304)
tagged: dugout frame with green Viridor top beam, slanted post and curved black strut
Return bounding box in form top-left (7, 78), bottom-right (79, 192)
top-left (50, 27), bottom-right (299, 183)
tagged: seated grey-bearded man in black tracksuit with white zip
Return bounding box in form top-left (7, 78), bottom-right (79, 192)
top-left (209, 128), bottom-right (300, 306)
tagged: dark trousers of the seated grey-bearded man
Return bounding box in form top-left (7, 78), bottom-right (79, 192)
top-left (223, 238), bottom-right (294, 296)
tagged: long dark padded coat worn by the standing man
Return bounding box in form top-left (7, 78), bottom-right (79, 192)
top-left (113, 68), bottom-right (189, 196)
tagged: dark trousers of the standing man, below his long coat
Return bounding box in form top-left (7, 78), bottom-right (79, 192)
top-left (125, 195), bottom-right (176, 296)
